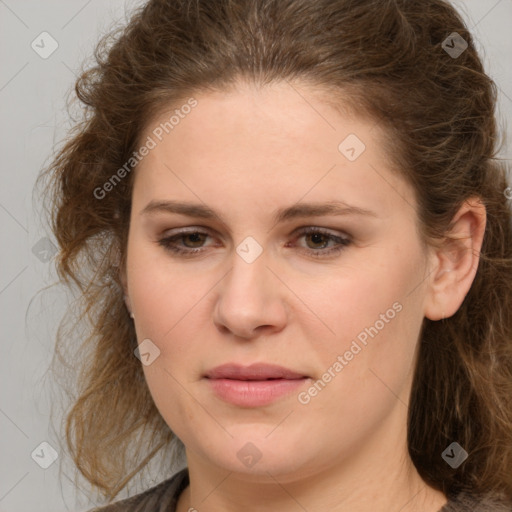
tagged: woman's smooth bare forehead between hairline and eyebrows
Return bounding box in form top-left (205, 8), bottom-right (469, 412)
top-left (134, 83), bottom-right (410, 221)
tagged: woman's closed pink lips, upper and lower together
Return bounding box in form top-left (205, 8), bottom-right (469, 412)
top-left (205, 363), bottom-right (309, 407)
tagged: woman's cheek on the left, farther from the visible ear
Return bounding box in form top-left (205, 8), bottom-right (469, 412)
top-left (129, 254), bottom-right (211, 432)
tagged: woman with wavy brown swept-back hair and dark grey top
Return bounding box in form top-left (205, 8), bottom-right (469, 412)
top-left (40, 0), bottom-right (512, 512)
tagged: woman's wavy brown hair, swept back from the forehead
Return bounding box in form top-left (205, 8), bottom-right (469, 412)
top-left (40, 0), bottom-right (512, 498)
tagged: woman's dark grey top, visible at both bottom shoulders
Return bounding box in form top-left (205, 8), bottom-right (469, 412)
top-left (90, 468), bottom-right (512, 512)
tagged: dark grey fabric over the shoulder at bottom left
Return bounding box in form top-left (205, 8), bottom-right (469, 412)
top-left (89, 468), bottom-right (189, 512)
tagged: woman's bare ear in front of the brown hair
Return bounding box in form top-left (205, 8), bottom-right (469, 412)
top-left (425, 197), bottom-right (487, 320)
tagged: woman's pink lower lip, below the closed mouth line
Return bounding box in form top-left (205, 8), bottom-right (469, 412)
top-left (208, 377), bottom-right (307, 407)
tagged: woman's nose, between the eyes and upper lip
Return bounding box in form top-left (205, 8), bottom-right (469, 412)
top-left (213, 247), bottom-right (287, 340)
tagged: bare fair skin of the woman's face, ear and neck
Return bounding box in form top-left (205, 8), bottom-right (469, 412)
top-left (124, 83), bottom-right (485, 512)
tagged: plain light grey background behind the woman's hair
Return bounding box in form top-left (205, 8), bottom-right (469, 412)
top-left (0, 0), bottom-right (512, 512)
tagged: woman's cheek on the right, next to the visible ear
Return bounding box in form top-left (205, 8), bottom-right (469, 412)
top-left (316, 246), bottom-right (423, 404)
